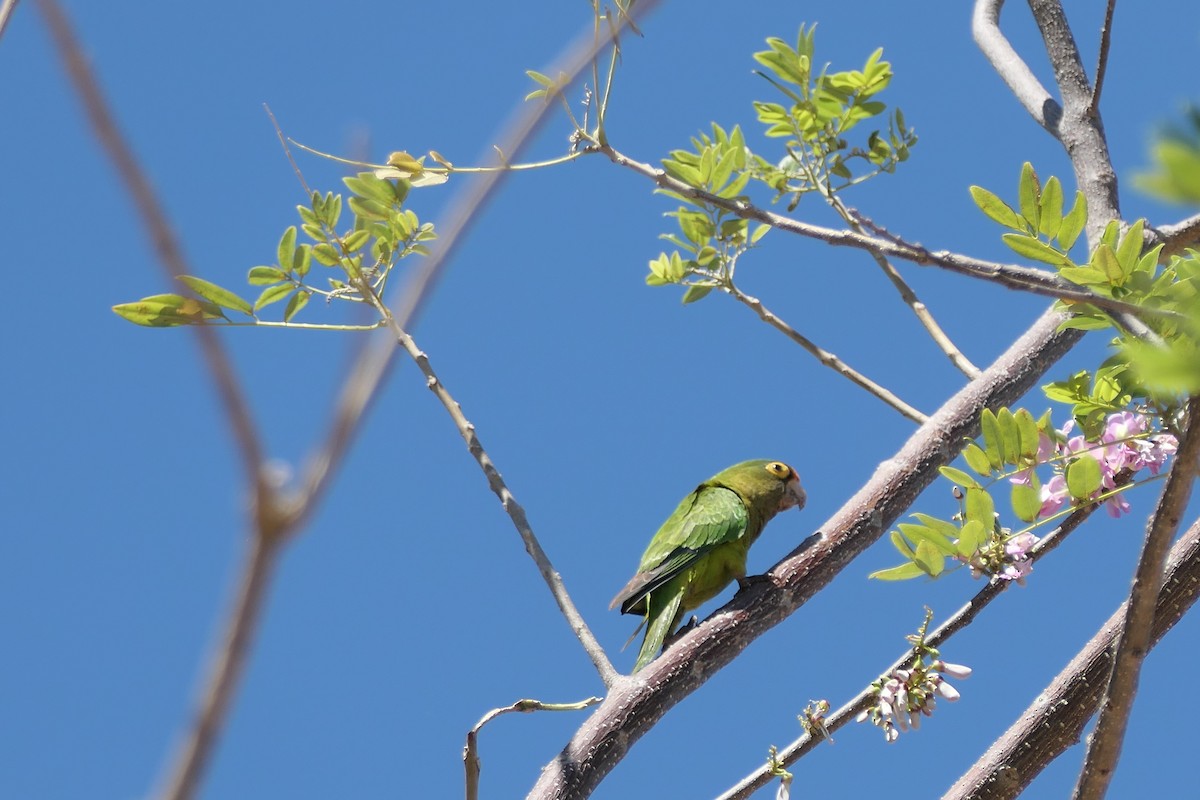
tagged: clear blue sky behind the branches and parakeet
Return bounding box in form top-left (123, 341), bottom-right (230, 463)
top-left (0, 0), bottom-right (1200, 798)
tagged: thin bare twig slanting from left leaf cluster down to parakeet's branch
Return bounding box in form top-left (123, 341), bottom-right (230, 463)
top-left (354, 279), bottom-right (620, 686)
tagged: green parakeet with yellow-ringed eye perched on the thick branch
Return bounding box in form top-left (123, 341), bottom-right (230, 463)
top-left (608, 461), bottom-right (806, 672)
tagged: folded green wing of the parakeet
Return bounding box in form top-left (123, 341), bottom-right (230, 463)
top-left (610, 486), bottom-right (749, 614)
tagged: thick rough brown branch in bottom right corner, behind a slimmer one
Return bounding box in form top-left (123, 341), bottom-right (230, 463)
top-left (942, 513), bottom-right (1200, 800)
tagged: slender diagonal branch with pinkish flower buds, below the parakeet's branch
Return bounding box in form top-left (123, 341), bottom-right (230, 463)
top-left (716, 505), bottom-right (1098, 800)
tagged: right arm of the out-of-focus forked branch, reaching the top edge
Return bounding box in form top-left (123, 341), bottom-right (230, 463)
top-left (294, 0), bottom-right (659, 525)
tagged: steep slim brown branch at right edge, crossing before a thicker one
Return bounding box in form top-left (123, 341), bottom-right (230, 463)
top-left (1074, 398), bottom-right (1200, 800)
